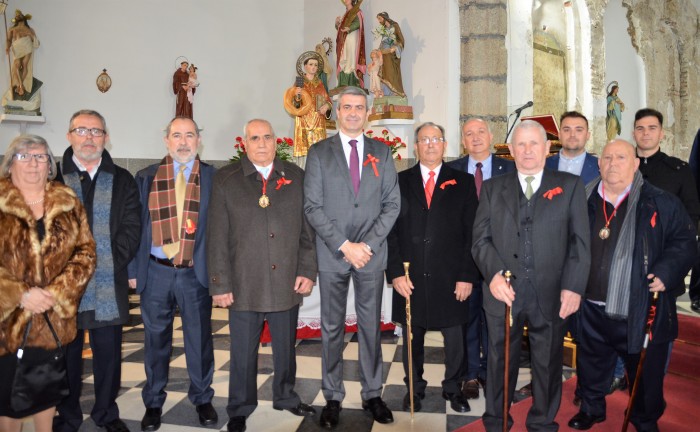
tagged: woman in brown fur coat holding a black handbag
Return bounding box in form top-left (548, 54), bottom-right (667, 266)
top-left (0, 135), bottom-right (96, 432)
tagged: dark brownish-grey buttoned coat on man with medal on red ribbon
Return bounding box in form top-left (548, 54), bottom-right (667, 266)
top-left (207, 157), bottom-right (317, 312)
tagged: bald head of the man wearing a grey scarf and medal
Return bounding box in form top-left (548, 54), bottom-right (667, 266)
top-left (598, 140), bottom-right (639, 193)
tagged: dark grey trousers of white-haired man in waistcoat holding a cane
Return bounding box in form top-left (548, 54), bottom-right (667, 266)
top-left (483, 284), bottom-right (568, 431)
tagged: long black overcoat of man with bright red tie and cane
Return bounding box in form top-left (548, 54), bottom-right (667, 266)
top-left (386, 164), bottom-right (479, 329)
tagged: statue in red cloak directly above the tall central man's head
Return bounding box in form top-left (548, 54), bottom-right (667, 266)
top-left (335, 0), bottom-right (367, 88)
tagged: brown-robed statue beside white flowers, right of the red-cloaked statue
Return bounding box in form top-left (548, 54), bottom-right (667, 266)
top-left (373, 12), bottom-right (406, 97)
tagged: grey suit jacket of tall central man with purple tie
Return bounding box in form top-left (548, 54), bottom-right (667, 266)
top-left (304, 135), bottom-right (401, 273)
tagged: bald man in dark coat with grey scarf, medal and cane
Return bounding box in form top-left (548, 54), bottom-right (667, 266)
top-left (569, 140), bottom-right (696, 431)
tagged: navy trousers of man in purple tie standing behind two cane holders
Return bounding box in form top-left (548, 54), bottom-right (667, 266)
top-left (463, 281), bottom-right (488, 381)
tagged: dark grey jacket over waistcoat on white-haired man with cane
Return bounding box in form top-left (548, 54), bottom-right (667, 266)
top-left (472, 169), bottom-right (591, 319)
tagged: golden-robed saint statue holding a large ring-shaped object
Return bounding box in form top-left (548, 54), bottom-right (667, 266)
top-left (284, 51), bottom-right (333, 157)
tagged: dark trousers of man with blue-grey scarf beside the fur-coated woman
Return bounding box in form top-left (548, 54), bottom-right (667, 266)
top-left (53, 325), bottom-right (122, 432)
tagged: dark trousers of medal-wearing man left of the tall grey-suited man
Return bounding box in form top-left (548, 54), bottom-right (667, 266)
top-left (226, 305), bottom-right (301, 417)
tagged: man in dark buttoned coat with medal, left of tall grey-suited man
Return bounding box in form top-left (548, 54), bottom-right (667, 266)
top-left (207, 120), bottom-right (318, 432)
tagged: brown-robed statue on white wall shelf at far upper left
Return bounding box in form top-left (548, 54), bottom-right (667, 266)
top-left (2, 9), bottom-right (42, 115)
